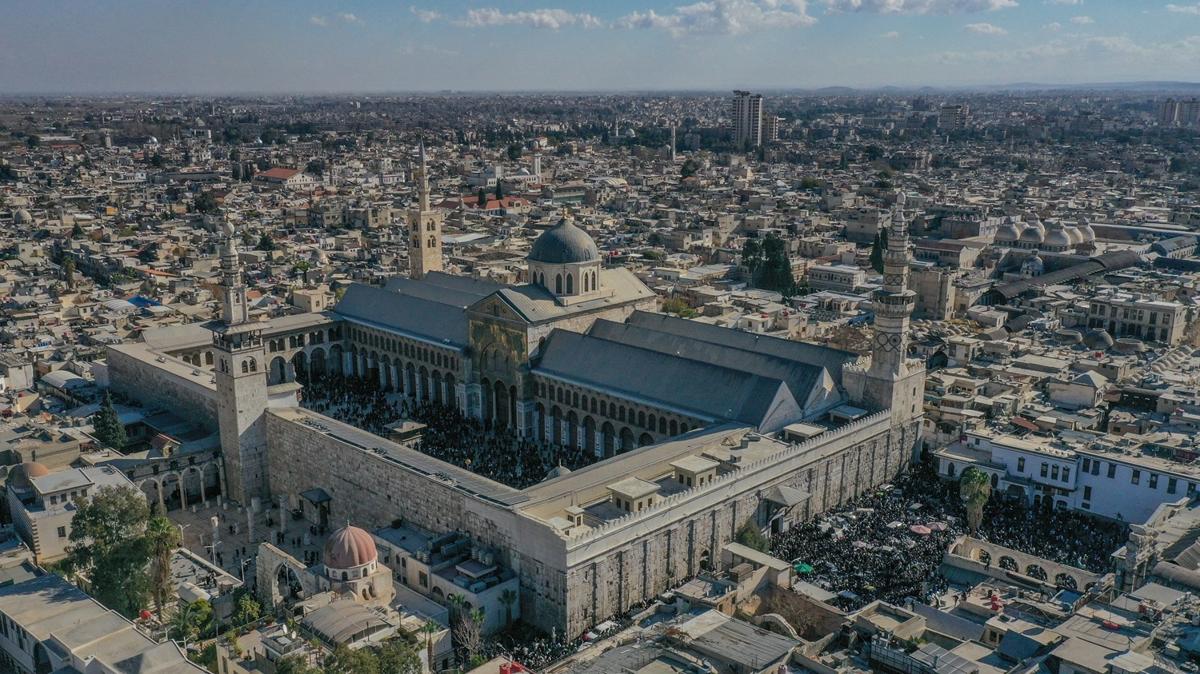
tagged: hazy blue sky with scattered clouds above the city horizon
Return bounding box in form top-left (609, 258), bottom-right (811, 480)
top-left (0, 0), bottom-right (1200, 94)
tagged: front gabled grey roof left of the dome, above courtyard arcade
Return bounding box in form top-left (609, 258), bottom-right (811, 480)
top-left (334, 283), bottom-right (467, 349)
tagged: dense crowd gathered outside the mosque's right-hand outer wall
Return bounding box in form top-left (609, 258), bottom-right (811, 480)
top-left (772, 464), bottom-right (1126, 609)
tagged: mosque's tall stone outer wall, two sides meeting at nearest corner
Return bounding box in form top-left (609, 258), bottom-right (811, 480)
top-left (266, 402), bottom-right (919, 636)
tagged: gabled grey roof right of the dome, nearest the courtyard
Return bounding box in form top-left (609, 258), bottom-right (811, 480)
top-left (533, 330), bottom-right (799, 428)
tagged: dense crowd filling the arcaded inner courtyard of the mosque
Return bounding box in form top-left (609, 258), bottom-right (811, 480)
top-left (301, 377), bottom-right (596, 489)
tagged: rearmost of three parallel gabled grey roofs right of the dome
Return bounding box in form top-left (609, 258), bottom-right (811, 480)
top-left (626, 312), bottom-right (858, 386)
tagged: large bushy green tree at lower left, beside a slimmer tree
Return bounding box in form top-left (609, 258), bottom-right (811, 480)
top-left (66, 487), bottom-right (151, 618)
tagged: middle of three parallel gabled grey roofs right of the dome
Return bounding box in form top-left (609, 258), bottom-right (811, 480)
top-left (588, 320), bottom-right (826, 405)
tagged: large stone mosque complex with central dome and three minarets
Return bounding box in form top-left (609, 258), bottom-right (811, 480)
top-left (108, 145), bottom-right (924, 634)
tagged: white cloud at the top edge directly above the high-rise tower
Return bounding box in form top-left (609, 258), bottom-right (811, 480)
top-left (614, 0), bottom-right (816, 37)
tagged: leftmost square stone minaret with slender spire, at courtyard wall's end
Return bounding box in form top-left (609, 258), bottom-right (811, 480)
top-left (212, 222), bottom-right (268, 505)
